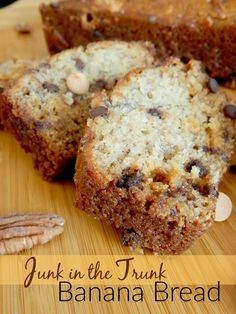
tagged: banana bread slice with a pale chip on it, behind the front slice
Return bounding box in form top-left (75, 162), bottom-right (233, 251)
top-left (0, 41), bottom-right (155, 180)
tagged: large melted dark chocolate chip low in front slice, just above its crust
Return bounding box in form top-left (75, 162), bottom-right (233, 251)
top-left (116, 169), bottom-right (144, 190)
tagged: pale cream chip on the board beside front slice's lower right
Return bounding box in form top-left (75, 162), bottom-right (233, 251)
top-left (215, 192), bottom-right (232, 221)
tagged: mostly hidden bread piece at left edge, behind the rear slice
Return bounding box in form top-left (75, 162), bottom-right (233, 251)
top-left (0, 60), bottom-right (35, 129)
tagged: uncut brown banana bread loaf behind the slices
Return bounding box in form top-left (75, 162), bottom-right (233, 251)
top-left (41, 0), bottom-right (236, 78)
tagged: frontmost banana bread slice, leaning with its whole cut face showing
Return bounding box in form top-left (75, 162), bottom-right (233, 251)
top-left (75, 59), bottom-right (234, 254)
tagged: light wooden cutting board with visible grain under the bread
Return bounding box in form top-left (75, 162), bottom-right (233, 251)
top-left (0, 0), bottom-right (236, 314)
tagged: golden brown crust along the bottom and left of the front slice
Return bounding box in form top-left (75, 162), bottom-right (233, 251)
top-left (75, 134), bottom-right (216, 254)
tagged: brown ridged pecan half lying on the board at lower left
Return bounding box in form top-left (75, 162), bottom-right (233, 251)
top-left (0, 214), bottom-right (65, 255)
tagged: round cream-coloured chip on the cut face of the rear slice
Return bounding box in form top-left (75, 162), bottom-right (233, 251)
top-left (66, 72), bottom-right (89, 95)
